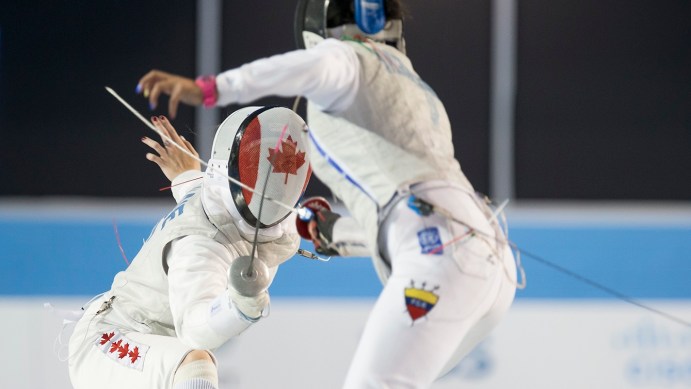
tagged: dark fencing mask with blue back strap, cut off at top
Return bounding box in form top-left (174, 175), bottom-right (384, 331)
top-left (294, 0), bottom-right (405, 53)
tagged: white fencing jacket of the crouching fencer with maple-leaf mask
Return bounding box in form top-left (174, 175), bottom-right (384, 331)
top-left (105, 172), bottom-right (299, 349)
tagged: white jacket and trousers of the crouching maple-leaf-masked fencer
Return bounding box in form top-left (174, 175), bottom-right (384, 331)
top-left (69, 172), bottom-right (299, 389)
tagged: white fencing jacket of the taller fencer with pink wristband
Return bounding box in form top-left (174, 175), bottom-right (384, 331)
top-left (217, 39), bottom-right (473, 280)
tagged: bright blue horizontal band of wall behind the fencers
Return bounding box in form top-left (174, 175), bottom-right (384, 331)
top-left (0, 211), bottom-right (691, 299)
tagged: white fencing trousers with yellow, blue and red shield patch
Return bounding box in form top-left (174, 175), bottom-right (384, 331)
top-left (344, 182), bottom-right (516, 389)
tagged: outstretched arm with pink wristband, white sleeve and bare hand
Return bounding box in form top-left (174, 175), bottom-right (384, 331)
top-left (137, 39), bottom-right (360, 118)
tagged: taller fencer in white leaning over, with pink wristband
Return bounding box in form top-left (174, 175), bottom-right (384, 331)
top-left (139, 0), bottom-right (517, 389)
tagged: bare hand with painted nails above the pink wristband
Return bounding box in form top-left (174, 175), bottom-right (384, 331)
top-left (137, 70), bottom-right (204, 119)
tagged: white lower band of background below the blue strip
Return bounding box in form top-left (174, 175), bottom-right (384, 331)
top-left (0, 297), bottom-right (691, 389)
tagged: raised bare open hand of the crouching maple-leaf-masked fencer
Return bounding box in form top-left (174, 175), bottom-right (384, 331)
top-left (142, 116), bottom-right (201, 181)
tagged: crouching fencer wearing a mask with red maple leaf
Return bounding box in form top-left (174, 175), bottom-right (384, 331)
top-left (69, 107), bottom-right (309, 389)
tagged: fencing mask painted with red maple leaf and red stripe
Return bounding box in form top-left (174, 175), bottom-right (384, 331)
top-left (207, 106), bottom-right (311, 228)
